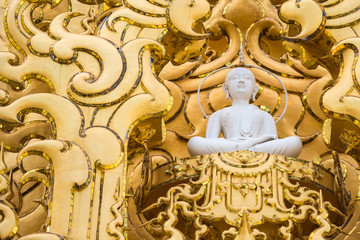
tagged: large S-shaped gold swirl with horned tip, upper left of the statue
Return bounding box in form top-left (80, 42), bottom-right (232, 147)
top-left (28, 13), bottom-right (168, 107)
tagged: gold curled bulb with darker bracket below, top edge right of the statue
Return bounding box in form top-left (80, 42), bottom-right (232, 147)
top-left (279, 0), bottom-right (339, 77)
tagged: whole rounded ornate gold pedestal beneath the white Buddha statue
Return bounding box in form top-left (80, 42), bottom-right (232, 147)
top-left (137, 151), bottom-right (354, 239)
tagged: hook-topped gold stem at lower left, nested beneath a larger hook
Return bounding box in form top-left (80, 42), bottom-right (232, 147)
top-left (18, 140), bottom-right (92, 234)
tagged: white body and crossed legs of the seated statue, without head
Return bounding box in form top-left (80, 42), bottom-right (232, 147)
top-left (188, 104), bottom-right (302, 157)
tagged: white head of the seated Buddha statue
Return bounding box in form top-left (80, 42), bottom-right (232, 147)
top-left (222, 67), bottom-right (259, 101)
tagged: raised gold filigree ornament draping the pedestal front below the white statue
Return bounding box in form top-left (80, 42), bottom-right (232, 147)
top-left (143, 151), bottom-right (336, 240)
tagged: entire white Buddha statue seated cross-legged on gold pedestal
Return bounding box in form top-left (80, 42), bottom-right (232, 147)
top-left (188, 68), bottom-right (302, 157)
